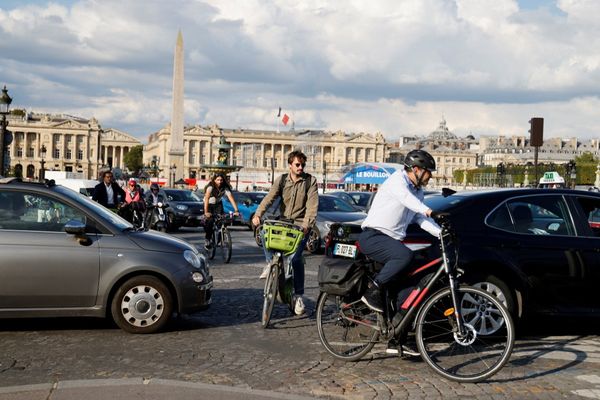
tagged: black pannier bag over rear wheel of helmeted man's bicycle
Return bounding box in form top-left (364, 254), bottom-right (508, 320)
top-left (318, 257), bottom-right (365, 296)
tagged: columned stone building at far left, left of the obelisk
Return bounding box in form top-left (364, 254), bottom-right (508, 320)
top-left (8, 112), bottom-right (141, 179)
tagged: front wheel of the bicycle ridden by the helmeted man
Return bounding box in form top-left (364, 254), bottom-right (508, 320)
top-left (416, 286), bottom-right (515, 382)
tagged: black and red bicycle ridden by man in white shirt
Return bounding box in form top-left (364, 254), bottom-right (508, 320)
top-left (316, 216), bottom-right (515, 382)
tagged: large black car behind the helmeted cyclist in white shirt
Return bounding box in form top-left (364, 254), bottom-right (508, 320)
top-left (326, 189), bottom-right (600, 320)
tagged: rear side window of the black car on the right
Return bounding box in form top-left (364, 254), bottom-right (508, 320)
top-left (486, 195), bottom-right (575, 236)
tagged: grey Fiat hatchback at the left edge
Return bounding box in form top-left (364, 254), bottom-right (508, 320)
top-left (0, 178), bottom-right (213, 333)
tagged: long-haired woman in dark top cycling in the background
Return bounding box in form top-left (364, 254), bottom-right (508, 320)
top-left (204, 174), bottom-right (240, 249)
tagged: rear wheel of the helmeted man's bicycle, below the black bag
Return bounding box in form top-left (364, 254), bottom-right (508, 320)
top-left (317, 293), bottom-right (379, 361)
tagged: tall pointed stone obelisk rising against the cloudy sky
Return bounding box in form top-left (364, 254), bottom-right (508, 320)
top-left (169, 30), bottom-right (185, 187)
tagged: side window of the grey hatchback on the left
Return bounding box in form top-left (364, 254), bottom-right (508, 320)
top-left (0, 191), bottom-right (87, 232)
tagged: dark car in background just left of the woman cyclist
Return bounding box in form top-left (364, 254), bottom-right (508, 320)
top-left (163, 189), bottom-right (204, 230)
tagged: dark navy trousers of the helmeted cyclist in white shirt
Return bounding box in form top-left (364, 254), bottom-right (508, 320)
top-left (358, 228), bottom-right (413, 285)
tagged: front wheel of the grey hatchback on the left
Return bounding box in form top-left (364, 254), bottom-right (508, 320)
top-left (111, 275), bottom-right (173, 333)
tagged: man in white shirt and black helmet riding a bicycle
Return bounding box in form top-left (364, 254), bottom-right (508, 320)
top-left (359, 150), bottom-right (441, 312)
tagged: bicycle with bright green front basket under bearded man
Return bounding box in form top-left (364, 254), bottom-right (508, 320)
top-left (261, 220), bottom-right (304, 328)
